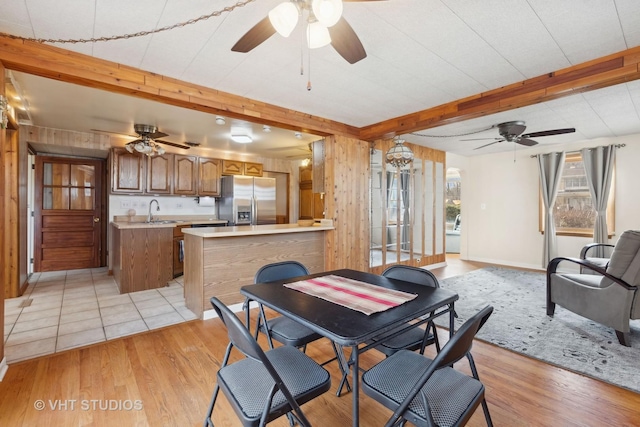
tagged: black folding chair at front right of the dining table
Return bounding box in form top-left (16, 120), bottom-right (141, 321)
top-left (362, 306), bottom-right (493, 427)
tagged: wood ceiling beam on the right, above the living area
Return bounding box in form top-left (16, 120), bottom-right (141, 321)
top-left (360, 47), bottom-right (640, 141)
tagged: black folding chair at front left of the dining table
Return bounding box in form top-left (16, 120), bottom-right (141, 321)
top-left (204, 297), bottom-right (331, 427)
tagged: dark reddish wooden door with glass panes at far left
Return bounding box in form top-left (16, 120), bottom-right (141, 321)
top-left (34, 156), bottom-right (106, 271)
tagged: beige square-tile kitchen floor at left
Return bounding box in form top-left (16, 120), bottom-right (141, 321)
top-left (4, 267), bottom-right (196, 363)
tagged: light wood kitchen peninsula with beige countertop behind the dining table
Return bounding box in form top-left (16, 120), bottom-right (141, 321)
top-left (179, 224), bottom-right (334, 318)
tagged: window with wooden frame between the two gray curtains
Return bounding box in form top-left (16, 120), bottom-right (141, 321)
top-left (540, 152), bottom-right (615, 236)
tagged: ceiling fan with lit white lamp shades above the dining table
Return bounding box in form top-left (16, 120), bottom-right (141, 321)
top-left (231, 0), bottom-right (381, 64)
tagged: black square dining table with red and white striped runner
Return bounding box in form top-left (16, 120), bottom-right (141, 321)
top-left (240, 269), bottom-right (458, 426)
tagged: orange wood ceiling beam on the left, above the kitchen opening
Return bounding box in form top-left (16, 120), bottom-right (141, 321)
top-left (0, 35), bottom-right (359, 137)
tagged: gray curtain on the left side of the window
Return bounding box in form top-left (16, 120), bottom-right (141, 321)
top-left (538, 152), bottom-right (565, 268)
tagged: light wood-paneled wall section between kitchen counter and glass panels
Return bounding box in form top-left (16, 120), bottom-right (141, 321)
top-left (324, 136), bottom-right (370, 271)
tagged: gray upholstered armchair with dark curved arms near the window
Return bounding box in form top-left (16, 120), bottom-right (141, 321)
top-left (547, 231), bottom-right (640, 346)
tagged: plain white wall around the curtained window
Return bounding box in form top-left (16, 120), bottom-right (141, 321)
top-left (447, 135), bottom-right (640, 269)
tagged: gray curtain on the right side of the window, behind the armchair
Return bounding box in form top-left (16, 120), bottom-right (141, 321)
top-left (580, 145), bottom-right (616, 258)
